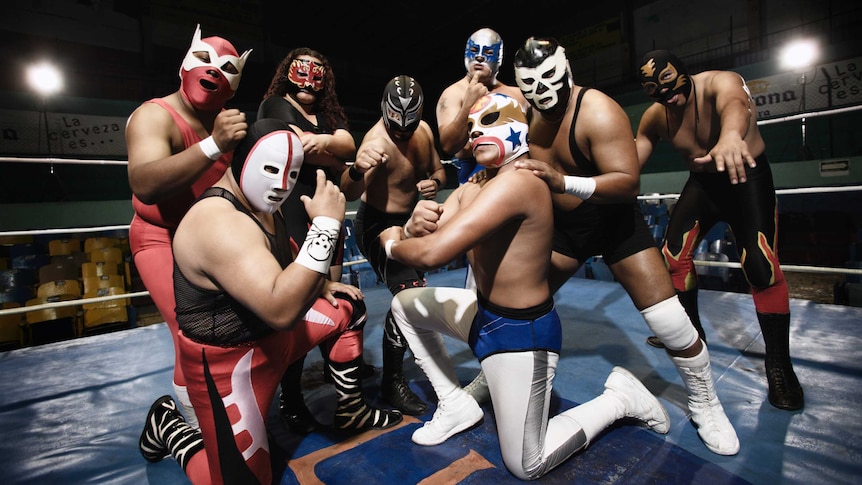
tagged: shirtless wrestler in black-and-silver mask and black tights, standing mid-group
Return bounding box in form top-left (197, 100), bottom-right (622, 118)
top-left (341, 75), bottom-right (446, 415)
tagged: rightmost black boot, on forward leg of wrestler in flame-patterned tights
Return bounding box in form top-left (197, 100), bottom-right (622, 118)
top-left (757, 312), bottom-right (805, 411)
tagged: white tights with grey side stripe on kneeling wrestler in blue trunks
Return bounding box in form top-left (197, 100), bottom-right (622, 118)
top-left (392, 287), bottom-right (625, 480)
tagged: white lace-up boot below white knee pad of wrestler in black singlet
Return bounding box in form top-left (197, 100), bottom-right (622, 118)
top-left (670, 344), bottom-right (739, 455)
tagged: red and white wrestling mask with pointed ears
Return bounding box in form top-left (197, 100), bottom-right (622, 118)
top-left (180, 24), bottom-right (251, 111)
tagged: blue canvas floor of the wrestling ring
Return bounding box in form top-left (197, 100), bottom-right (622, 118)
top-left (0, 269), bottom-right (862, 485)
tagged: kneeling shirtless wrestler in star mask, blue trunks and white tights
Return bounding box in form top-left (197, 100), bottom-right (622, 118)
top-left (381, 94), bottom-right (668, 480)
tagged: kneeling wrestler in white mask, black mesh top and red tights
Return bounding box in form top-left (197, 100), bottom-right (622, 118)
top-left (140, 119), bottom-right (402, 483)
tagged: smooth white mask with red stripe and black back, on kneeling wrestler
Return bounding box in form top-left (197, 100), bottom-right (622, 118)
top-left (231, 118), bottom-right (305, 214)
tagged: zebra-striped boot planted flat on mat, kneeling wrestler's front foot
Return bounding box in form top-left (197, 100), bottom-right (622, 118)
top-left (329, 356), bottom-right (404, 433)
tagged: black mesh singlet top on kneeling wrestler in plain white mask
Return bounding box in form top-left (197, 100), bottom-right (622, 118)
top-left (174, 187), bottom-right (293, 347)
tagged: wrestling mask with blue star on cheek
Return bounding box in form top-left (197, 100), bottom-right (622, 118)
top-left (467, 93), bottom-right (530, 168)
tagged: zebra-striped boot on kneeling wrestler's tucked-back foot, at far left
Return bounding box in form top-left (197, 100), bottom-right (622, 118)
top-left (138, 396), bottom-right (204, 470)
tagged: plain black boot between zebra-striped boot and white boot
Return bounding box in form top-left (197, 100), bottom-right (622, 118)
top-left (380, 312), bottom-right (428, 416)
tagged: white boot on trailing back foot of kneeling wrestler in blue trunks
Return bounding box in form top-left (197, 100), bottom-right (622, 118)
top-left (604, 366), bottom-right (670, 434)
